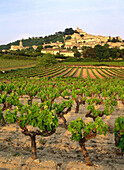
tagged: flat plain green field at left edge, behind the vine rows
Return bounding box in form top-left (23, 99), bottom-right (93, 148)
top-left (0, 58), bottom-right (37, 70)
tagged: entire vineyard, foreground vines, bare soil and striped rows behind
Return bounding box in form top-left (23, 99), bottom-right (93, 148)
top-left (0, 71), bottom-right (124, 169)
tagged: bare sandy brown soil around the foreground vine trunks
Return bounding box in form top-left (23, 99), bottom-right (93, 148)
top-left (0, 102), bottom-right (124, 170)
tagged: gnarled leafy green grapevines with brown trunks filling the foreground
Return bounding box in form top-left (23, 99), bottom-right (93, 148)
top-left (0, 76), bottom-right (124, 165)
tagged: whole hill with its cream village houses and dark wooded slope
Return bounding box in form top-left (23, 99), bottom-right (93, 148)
top-left (0, 27), bottom-right (124, 52)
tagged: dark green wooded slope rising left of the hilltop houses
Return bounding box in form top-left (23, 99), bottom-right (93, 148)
top-left (0, 28), bottom-right (75, 51)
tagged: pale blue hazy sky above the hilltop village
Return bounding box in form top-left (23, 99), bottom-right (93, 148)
top-left (0, 0), bottom-right (124, 45)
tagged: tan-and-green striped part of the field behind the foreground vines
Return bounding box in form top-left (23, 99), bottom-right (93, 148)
top-left (51, 66), bottom-right (124, 79)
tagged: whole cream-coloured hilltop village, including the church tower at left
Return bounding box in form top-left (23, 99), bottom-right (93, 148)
top-left (10, 27), bottom-right (124, 57)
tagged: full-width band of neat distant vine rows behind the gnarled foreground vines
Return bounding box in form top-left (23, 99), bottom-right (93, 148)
top-left (0, 65), bottom-right (124, 79)
